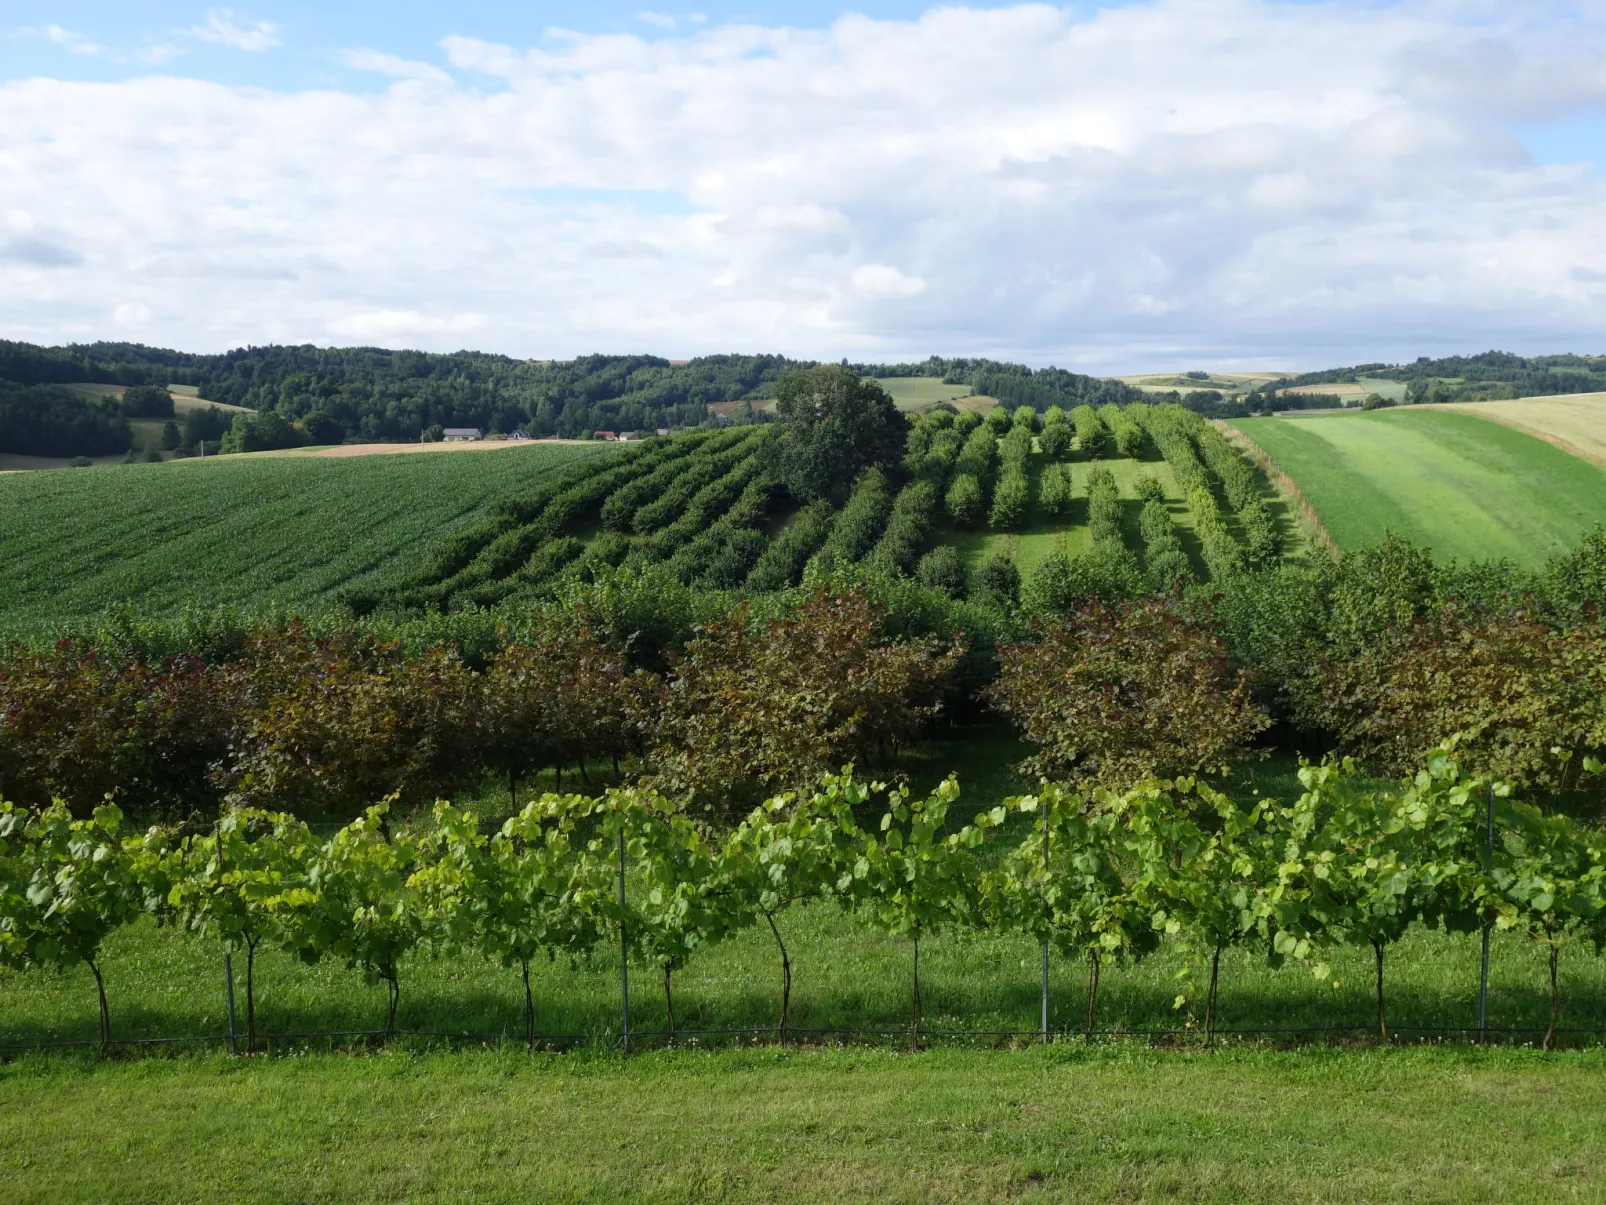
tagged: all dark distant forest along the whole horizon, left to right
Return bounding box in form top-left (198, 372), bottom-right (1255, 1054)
top-left (0, 341), bottom-right (1606, 456)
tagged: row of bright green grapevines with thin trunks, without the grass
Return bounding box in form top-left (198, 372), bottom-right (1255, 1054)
top-left (0, 755), bottom-right (1606, 1049)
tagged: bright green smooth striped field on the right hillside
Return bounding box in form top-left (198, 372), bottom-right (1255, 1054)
top-left (1233, 410), bottom-right (1606, 567)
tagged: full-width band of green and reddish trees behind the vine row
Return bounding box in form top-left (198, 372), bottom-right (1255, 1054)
top-left (12, 536), bottom-right (1606, 815)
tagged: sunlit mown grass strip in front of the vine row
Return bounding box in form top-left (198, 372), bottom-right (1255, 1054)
top-left (0, 1048), bottom-right (1606, 1205)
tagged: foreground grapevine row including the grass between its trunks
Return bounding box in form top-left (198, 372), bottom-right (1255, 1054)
top-left (9, 749), bottom-right (1606, 1051)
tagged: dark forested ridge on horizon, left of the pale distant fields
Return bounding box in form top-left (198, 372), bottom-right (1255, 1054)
top-left (0, 341), bottom-right (1142, 456)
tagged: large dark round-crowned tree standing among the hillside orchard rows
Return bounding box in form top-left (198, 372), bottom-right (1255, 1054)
top-left (776, 365), bottom-right (909, 503)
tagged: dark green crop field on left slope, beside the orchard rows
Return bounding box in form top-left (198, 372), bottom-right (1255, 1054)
top-left (0, 445), bottom-right (605, 630)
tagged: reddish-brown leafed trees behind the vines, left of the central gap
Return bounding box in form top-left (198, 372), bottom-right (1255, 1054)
top-left (0, 588), bottom-right (962, 818)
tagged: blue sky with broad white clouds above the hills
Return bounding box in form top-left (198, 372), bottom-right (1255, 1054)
top-left (0, 0), bottom-right (1606, 373)
